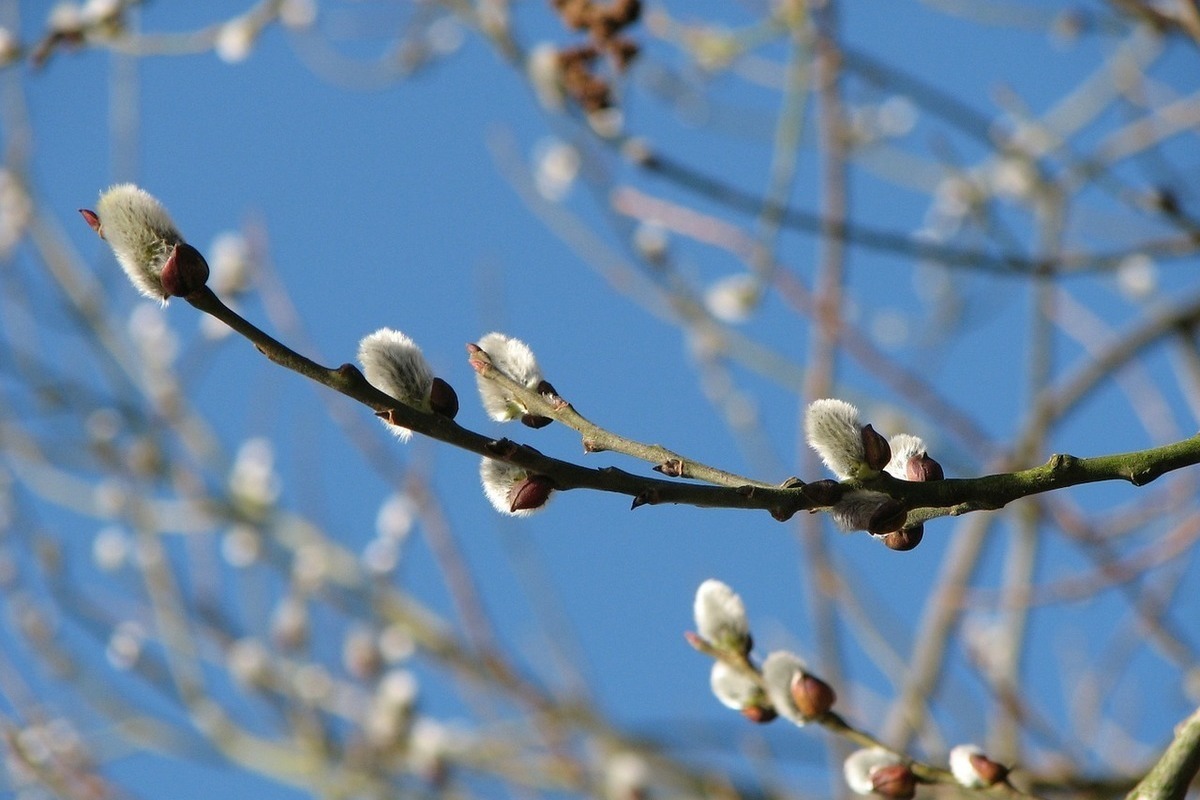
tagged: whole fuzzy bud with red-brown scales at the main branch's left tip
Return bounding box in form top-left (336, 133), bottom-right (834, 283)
top-left (79, 184), bottom-right (209, 302)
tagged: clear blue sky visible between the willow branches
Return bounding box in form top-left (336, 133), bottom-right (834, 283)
top-left (0, 0), bottom-right (1200, 796)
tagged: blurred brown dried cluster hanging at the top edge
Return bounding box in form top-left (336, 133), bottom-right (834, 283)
top-left (551, 0), bottom-right (642, 113)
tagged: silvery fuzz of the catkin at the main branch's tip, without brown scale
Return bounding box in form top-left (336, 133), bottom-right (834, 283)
top-left (96, 184), bottom-right (184, 302)
